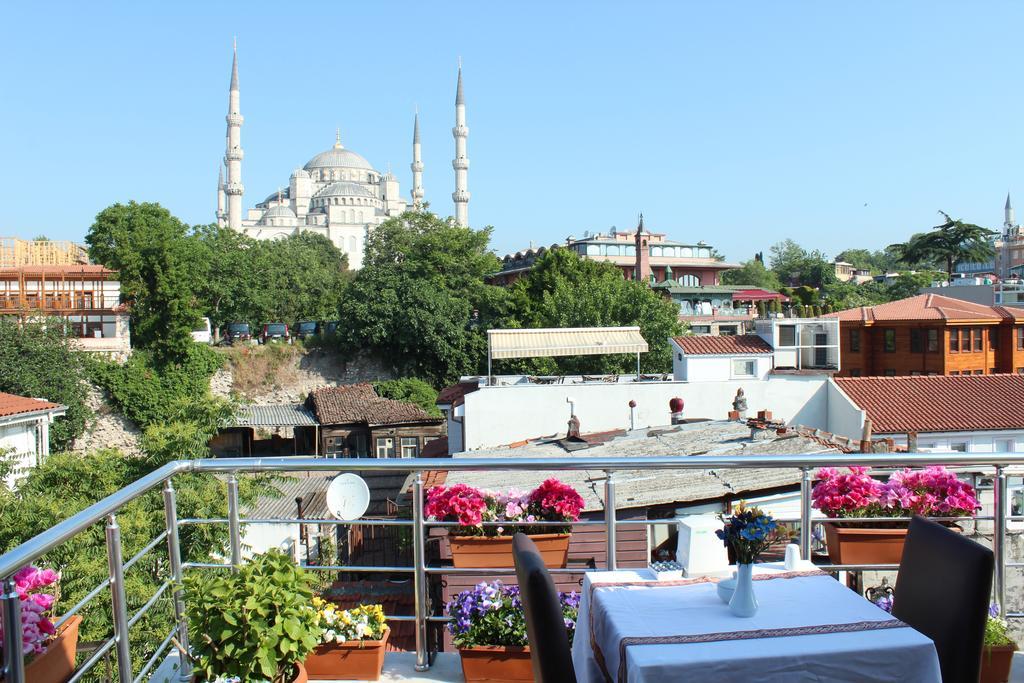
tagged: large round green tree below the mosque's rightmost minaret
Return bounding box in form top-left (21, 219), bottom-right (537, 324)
top-left (337, 211), bottom-right (507, 386)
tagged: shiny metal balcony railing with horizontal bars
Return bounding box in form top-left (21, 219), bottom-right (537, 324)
top-left (0, 454), bottom-right (1024, 683)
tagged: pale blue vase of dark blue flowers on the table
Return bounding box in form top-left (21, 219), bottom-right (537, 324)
top-left (715, 501), bottom-right (784, 616)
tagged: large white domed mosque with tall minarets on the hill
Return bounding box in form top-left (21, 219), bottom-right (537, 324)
top-left (217, 48), bottom-right (469, 269)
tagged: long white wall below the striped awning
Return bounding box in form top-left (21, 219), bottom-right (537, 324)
top-left (462, 376), bottom-right (828, 453)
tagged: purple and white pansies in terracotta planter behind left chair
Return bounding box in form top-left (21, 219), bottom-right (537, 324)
top-left (445, 581), bottom-right (580, 683)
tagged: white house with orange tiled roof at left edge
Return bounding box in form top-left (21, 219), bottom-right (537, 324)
top-left (0, 392), bottom-right (68, 488)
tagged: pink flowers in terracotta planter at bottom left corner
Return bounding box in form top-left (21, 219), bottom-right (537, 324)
top-left (0, 565), bottom-right (82, 683)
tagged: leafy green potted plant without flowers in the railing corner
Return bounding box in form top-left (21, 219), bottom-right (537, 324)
top-left (185, 550), bottom-right (324, 683)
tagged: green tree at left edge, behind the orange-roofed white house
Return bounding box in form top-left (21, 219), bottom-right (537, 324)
top-left (0, 317), bottom-right (90, 452)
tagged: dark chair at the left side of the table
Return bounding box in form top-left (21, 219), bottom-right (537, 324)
top-left (512, 533), bottom-right (575, 683)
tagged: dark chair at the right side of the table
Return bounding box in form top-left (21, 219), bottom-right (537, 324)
top-left (893, 516), bottom-right (995, 683)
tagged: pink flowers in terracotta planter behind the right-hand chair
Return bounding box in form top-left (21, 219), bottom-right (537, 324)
top-left (811, 467), bottom-right (979, 564)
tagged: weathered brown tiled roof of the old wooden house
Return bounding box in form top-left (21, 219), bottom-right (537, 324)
top-left (309, 384), bottom-right (441, 425)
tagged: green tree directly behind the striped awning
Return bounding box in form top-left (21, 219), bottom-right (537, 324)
top-left (501, 249), bottom-right (682, 374)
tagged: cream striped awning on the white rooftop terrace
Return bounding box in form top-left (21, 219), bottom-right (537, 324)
top-left (487, 328), bottom-right (647, 358)
